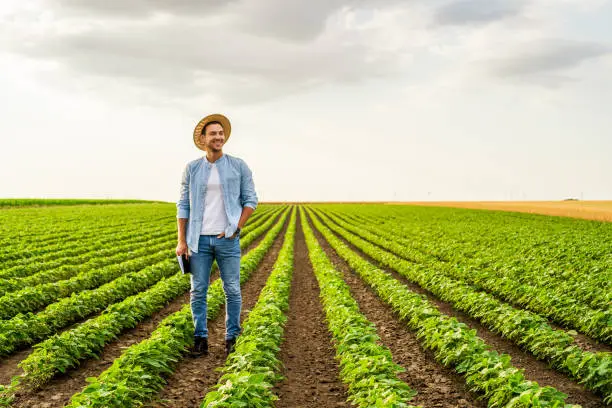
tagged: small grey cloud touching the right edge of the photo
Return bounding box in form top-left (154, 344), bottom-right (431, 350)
top-left (489, 39), bottom-right (612, 82)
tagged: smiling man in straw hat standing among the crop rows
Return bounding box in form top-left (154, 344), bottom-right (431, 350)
top-left (176, 114), bottom-right (257, 357)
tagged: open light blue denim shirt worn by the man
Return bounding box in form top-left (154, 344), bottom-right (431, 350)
top-left (176, 154), bottom-right (257, 252)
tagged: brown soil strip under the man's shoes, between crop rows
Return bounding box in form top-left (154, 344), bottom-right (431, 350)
top-left (147, 218), bottom-right (288, 408)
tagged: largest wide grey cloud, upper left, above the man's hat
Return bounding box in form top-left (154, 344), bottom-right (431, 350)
top-left (7, 10), bottom-right (412, 103)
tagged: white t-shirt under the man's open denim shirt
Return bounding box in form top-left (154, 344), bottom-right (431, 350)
top-left (200, 159), bottom-right (227, 235)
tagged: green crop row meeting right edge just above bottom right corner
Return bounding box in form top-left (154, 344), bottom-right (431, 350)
top-left (317, 212), bottom-right (612, 402)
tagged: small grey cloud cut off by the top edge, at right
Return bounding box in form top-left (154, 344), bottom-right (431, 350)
top-left (434, 0), bottom-right (525, 25)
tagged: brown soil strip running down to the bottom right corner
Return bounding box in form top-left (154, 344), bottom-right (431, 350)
top-left (310, 215), bottom-right (604, 408)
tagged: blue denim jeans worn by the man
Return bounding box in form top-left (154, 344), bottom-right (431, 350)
top-left (190, 235), bottom-right (242, 339)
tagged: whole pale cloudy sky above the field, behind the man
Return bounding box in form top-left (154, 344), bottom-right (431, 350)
top-left (0, 0), bottom-right (612, 201)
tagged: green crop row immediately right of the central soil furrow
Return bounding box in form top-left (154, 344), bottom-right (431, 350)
top-left (301, 210), bottom-right (416, 407)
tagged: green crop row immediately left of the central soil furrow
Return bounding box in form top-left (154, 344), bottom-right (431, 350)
top-left (202, 209), bottom-right (296, 408)
